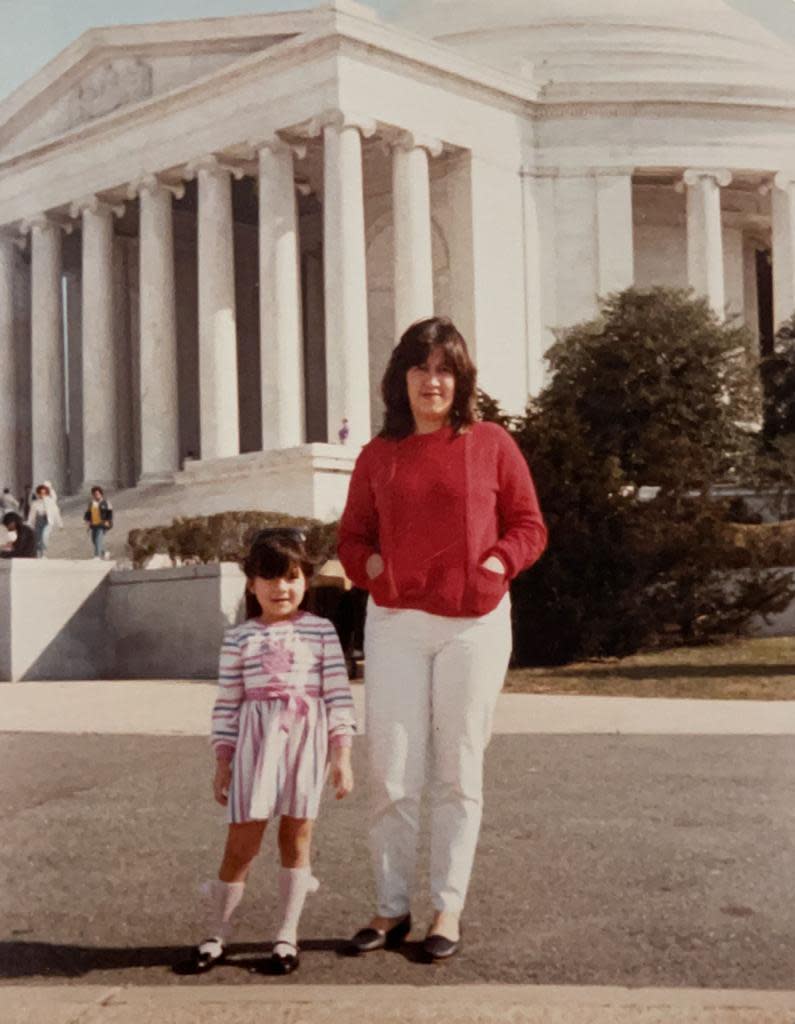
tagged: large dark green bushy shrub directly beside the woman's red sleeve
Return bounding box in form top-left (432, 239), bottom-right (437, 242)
top-left (493, 288), bottom-right (793, 664)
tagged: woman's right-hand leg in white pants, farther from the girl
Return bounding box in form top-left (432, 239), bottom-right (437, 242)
top-left (430, 598), bottom-right (511, 940)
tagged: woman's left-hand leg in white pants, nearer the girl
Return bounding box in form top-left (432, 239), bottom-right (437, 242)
top-left (365, 600), bottom-right (433, 931)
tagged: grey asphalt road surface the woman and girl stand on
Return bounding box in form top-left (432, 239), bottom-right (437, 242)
top-left (0, 732), bottom-right (795, 990)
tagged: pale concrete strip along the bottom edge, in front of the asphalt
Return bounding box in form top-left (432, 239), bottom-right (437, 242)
top-left (0, 985), bottom-right (795, 1024)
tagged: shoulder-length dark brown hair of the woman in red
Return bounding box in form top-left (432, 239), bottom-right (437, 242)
top-left (380, 316), bottom-right (477, 440)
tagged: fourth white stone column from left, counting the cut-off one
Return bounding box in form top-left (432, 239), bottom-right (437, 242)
top-left (130, 175), bottom-right (184, 482)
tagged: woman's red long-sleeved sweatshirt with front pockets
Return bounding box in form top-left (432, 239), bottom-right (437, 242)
top-left (338, 423), bottom-right (547, 616)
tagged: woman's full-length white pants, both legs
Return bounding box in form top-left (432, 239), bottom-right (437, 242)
top-left (365, 594), bottom-right (511, 918)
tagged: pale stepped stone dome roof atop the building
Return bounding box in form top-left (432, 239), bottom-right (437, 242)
top-left (395, 0), bottom-right (795, 86)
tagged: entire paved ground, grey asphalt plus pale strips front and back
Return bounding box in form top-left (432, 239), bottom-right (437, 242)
top-left (0, 681), bottom-right (795, 1024)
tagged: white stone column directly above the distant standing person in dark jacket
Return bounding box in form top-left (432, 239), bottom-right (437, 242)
top-left (72, 197), bottom-right (124, 488)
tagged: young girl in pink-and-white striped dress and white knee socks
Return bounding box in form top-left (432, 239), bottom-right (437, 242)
top-left (183, 529), bottom-right (355, 974)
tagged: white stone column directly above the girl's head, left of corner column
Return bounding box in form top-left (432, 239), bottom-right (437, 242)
top-left (257, 138), bottom-right (305, 450)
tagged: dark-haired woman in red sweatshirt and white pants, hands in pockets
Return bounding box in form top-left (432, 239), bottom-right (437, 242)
top-left (339, 317), bottom-right (546, 959)
